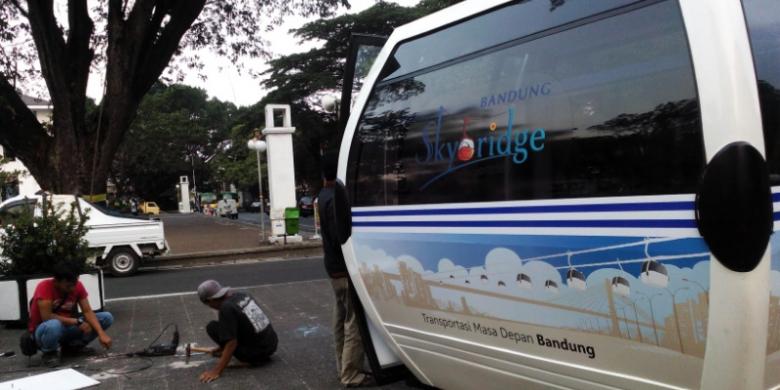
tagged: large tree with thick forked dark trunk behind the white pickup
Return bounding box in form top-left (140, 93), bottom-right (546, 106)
top-left (0, 0), bottom-right (349, 194)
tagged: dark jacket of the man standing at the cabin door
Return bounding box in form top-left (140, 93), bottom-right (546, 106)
top-left (317, 187), bottom-right (347, 278)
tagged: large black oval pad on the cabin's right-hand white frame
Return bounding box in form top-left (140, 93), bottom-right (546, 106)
top-left (696, 142), bottom-right (774, 272)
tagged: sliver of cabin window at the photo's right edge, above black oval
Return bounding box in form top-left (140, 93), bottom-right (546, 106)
top-left (743, 0), bottom-right (780, 178)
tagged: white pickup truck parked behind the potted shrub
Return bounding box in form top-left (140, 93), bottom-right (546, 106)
top-left (0, 195), bottom-right (168, 276)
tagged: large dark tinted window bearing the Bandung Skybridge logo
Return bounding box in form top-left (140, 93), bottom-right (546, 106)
top-left (348, 1), bottom-right (705, 205)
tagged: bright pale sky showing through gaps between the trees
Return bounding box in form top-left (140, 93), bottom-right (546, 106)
top-left (87, 0), bottom-right (419, 106)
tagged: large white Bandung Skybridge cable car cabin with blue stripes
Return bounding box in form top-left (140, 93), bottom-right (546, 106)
top-left (337, 0), bottom-right (780, 389)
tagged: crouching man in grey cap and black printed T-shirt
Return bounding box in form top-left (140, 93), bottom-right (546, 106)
top-left (198, 280), bottom-right (278, 383)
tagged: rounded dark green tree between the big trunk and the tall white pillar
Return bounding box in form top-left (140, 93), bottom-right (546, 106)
top-left (112, 83), bottom-right (236, 208)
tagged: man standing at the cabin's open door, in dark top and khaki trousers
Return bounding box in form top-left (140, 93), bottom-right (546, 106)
top-left (317, 152), bottom-right (372, 387)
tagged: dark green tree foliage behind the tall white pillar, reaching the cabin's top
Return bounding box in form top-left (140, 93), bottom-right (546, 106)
top-left (211, 0), bottom-right (459, 190)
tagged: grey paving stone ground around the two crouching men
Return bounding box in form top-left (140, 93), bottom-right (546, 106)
top-left (0, 280), bottom-right (418, 389)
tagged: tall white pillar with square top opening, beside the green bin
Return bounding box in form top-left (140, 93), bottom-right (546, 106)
top-left (263, 104), bottom-right (303, 243)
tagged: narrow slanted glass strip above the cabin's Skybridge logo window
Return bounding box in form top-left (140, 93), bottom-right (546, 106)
top-left (386, 0), bottom-right (637, 79)
